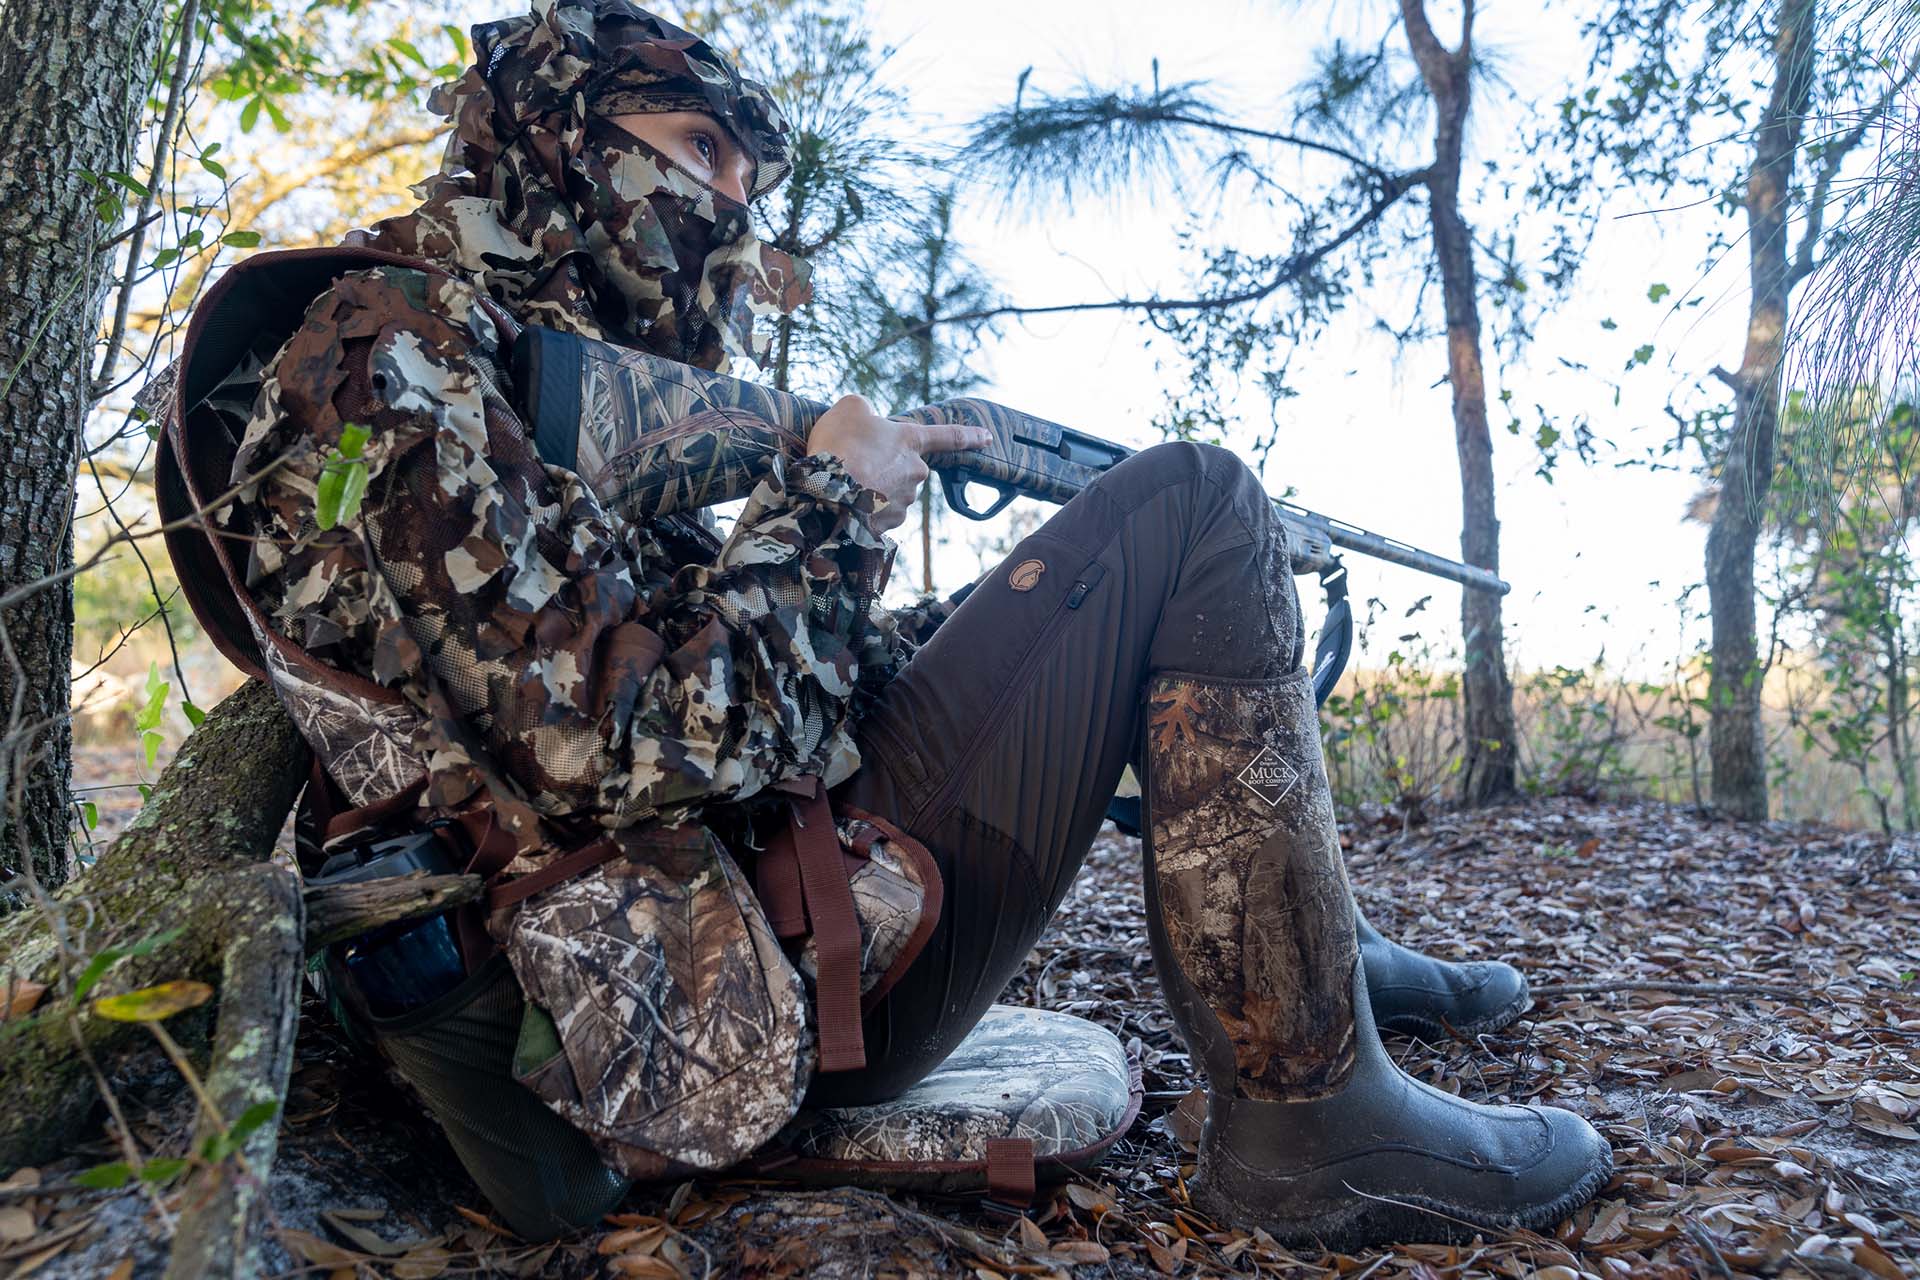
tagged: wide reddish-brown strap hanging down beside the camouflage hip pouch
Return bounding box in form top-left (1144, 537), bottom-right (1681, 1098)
top-left (768, 777), bottom-right (866, 1071)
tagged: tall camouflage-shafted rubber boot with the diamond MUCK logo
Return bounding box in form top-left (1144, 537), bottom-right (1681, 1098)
top-left (1144, 672), bottom-right (1613, 1251)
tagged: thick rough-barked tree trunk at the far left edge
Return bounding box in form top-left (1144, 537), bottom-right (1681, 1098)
top-left (0, 0), bottom-right (163, 887)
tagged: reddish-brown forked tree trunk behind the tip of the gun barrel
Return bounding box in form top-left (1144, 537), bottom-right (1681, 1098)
top-left (1400, 0), bottom-right (1517, 804)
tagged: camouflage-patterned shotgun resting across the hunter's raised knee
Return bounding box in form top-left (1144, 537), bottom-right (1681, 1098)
top-left (513, 326), bottom-right (1507, 595)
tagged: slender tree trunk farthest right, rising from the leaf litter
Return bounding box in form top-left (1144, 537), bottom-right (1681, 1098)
top-left (1707, 0), bottom-right (1818, 821)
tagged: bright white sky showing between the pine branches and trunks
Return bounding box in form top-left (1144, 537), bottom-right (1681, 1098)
top-left (868, 0), bottom-right (1745, 670)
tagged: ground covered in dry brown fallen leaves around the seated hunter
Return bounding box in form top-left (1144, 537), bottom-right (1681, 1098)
top-left (0, 771), bottom-right (1920, 1280)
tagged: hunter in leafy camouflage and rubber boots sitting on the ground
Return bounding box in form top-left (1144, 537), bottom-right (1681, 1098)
top-left (194, 0), bottom-right (1611, 1247)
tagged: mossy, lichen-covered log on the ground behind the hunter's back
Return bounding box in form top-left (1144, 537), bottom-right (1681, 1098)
top-left (0, 681), bottom-right (307, 1276)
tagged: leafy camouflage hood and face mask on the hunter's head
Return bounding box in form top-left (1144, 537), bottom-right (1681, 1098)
top-left (371, 0), bottom-right (808, 372)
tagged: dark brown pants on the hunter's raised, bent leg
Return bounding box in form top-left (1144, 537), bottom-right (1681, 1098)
top-left (808, 443), bottom-right (1304, 1105)
